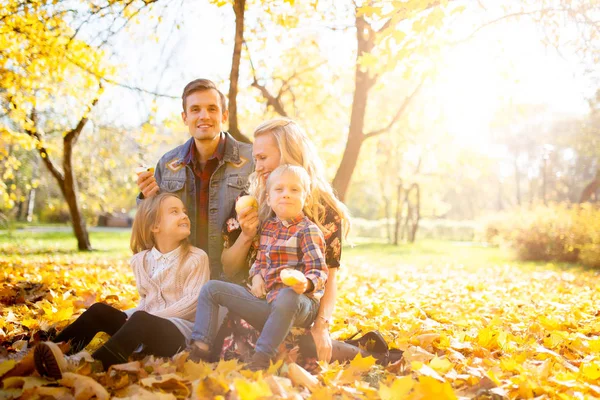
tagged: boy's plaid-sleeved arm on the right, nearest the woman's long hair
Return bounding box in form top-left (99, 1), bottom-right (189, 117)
top-left (300, 224), bottom-right (328, 293)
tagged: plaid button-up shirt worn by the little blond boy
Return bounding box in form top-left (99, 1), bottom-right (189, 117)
top-left (250, 214), bottom-right (327, 303)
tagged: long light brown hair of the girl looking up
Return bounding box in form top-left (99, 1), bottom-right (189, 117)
top-left (129, 193), bottom-right (191, 263)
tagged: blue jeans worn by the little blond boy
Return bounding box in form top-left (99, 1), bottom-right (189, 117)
top-left (192, 280), bottom-right (319, 358)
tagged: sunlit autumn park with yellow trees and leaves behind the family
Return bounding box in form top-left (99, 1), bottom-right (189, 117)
top-left (0, 0), bottom-right (600, 398)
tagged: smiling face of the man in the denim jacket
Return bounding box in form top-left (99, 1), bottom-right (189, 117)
top-left (181, 89), bottom-right (228, 141)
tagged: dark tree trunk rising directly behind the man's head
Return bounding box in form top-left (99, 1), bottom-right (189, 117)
top-left (229, 0), bottom-right (251, 143)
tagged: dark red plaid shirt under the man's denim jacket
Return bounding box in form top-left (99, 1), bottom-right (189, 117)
top-left (183, 132), bottom-right (226, 253)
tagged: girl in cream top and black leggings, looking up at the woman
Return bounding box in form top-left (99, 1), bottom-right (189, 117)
top-left (34, 193), bottom-right (210, 379)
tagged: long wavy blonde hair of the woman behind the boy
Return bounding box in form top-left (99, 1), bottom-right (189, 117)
top-left (250, 118), bottom-right (350, 236)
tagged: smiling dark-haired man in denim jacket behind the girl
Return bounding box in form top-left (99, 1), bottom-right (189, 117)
top-left (137, 79), bottom-right (254, 279)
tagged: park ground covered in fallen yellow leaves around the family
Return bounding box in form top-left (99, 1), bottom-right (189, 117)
top-left (0, 234), bottom-right (600, 400)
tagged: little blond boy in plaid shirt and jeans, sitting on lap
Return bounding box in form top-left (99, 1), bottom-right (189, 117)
top-left (190, 165), bottom-right (327, 370)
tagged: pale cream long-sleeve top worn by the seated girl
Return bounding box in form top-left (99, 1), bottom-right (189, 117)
top-left (125, 247), bottom-right (210, 339)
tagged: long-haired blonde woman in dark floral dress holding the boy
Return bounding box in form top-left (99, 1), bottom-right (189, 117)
top-left (192, 118), bottom-right (398, 367)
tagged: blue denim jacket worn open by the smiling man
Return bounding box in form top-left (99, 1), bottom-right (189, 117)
top-left (138, 133), bottom-right (254, 279)
